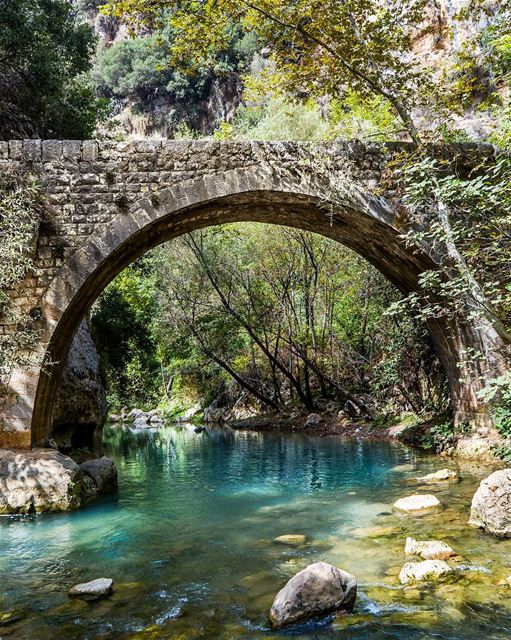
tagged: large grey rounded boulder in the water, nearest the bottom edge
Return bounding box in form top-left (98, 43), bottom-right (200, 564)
top-left (270, 562), bottom-right (357, 629)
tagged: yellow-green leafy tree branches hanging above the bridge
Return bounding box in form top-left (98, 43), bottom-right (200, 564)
top-left (104, 0), bottom-right (427, 142)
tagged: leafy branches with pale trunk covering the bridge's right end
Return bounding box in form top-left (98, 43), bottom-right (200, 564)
top-left (390, 154), bottom-right (511, 340)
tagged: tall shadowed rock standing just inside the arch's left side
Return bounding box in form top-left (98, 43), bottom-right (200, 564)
top-left (52, 320), bottom-right (108, 451)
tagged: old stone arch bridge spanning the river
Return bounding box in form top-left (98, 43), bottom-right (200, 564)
top-left (0, 140), bottom-right (510, 448)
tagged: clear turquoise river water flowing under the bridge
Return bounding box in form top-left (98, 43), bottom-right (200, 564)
top-left (0, 426), bottom-right (511, 640)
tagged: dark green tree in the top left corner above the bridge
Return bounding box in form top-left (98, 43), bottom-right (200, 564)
top-left (0, 0), bottom-right (105, 139)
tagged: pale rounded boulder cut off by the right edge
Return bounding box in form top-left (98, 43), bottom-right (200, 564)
top-left (469, 469), bottom-right (511, 538)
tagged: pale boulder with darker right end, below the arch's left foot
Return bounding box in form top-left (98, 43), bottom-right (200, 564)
top-left (0, 449), bottom-right (117, 513)
